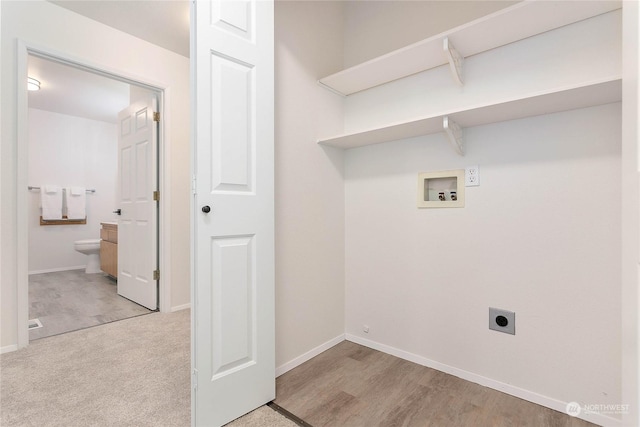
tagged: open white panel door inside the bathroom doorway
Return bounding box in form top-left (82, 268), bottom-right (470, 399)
top-left (118, 99), bottom-right (158, 310)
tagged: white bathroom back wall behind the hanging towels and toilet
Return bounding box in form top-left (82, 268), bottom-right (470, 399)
top-left (28, 108), bottom-right (118, 273)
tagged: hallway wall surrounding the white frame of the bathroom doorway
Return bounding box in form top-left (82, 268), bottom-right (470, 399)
top-left (0, 0), bottom-right (190, 348)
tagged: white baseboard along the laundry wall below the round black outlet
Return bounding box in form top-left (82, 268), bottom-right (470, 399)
top-left (345, 334), bottom-right (621, 427)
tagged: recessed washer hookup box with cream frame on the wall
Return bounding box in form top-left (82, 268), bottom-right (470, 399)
top-left (418, 169), bottom-right (464, 208)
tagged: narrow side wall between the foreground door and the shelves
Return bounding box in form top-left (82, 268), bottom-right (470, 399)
top-left (275, 1), bottom-right (345, 372)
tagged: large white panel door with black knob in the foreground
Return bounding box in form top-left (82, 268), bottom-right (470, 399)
top-left (192, 0), bottom-right (275, 426)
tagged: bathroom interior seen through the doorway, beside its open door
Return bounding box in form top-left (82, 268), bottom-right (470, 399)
top-left (27, 54), bottom-right (162, 340)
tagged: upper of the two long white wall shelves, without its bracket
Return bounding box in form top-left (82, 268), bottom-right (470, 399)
top-left (319, 0), bottom-right (622, 95)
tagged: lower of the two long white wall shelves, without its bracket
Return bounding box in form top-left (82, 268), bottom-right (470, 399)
top-left (318, 76), bottom-right (622, 149)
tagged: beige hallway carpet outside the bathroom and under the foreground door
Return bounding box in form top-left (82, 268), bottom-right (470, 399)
top-left (0, 310), bottom-right (296, 427)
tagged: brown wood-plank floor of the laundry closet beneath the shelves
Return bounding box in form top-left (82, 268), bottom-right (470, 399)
top-left (275, 341), bottom-right (594, 427)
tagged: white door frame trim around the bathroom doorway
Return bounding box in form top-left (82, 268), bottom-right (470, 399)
top-left (15, 40), bottom-right (171, 349)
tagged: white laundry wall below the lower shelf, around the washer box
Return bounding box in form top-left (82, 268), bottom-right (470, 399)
top-left (345, 104), bottom-right (621, 420)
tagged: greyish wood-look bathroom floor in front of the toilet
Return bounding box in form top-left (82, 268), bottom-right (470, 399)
top-left (29, 270), bottom-right (152, 340)
